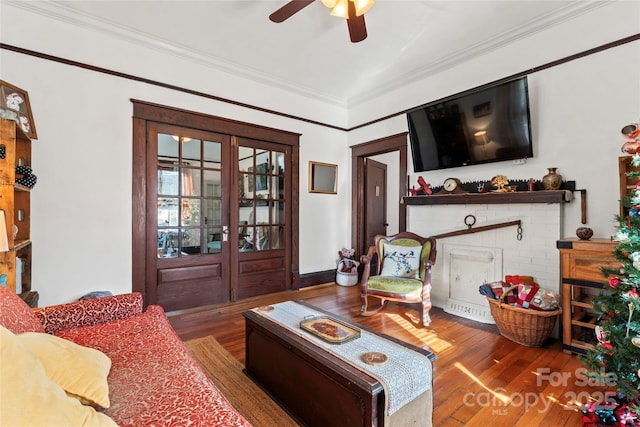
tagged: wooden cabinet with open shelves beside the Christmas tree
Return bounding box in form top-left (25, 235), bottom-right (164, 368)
top-left (556, 238), bottom-right (621, 354)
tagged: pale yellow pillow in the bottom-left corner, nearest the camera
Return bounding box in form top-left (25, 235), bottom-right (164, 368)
top-left (0, 326), bottom-right (117, 427)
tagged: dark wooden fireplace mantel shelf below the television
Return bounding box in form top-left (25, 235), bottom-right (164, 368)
top-left (402, 190), bottom-right (572, 205)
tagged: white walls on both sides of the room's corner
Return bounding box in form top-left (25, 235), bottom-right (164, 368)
top-left (0, 2), bottom-right (640, 305)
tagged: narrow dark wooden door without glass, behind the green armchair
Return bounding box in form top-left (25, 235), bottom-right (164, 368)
top-left (364, 159), bottom-right (388, 247)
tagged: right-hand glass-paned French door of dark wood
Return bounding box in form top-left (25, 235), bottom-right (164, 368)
top-left (231, 138), bottom-right (292, 299)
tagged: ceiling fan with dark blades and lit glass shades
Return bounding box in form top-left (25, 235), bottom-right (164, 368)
top-left (269, 0), bottom-right (374, 43)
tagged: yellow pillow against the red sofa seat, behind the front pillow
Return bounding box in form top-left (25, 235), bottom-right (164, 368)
top-left (16, 332), bottom-right (111, 408)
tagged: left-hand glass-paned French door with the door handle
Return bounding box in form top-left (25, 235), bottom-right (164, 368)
top-left (146, 123), bottom-right (233, 310)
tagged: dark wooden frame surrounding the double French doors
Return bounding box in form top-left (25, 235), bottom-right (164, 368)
top-left (131, 99), bottom-right (300, 306)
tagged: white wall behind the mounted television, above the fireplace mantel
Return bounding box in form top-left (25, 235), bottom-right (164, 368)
top-left (349, 1), bottom-right (640, 241)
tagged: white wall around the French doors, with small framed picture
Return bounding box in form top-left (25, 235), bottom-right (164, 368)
top-left (0, 4), bottom-right (351, 305)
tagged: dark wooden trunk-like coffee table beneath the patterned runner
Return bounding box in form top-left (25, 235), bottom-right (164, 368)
top-left (243, 301), bottom-right (435, 427)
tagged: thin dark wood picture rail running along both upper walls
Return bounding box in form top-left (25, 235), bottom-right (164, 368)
top-left (0, 34), bottom-right (640, 132)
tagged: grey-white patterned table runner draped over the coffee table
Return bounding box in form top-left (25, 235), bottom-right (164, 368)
top-left (252, 301), bottom-right (432, 416)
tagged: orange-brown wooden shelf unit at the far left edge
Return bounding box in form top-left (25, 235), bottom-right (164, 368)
top-left (0, 119), bottom-right (38, 307)
